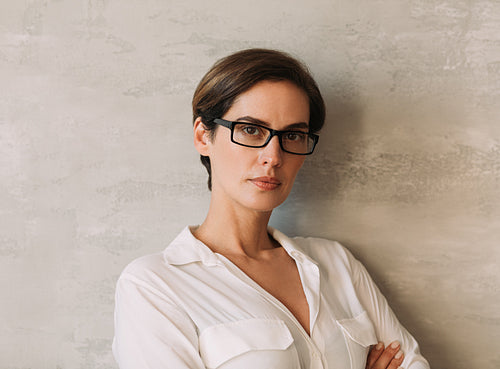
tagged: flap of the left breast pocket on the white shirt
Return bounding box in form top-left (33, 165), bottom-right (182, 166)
top-left (200, 319), bottom-right (293, 368)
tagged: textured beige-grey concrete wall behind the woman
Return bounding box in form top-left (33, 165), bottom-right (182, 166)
top-left (0, 0), bottom-right (500, 369)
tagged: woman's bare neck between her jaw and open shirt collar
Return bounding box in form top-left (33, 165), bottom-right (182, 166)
top-left (193, 193), bottom-right (275, 258)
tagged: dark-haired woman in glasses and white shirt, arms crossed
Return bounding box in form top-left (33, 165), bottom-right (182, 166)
top-left (113, 49), bottom-right (429, 369)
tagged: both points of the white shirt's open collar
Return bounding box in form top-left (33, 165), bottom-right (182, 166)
top-left (163, 226), bottom-right (318, 266)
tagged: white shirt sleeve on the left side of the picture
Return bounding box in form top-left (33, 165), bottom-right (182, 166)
top-left (113, 274), bottom-right (205, 369)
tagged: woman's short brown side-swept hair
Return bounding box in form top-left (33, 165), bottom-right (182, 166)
top-left (192, 49), bottom-right (325, 190)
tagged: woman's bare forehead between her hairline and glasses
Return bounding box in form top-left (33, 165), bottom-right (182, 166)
top-left (223, 81), bottom-right (309, 128)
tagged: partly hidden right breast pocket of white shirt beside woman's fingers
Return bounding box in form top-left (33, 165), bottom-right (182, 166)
top-left (337, 311), bottom-right (377, 369)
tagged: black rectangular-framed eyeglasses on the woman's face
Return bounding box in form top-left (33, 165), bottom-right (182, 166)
top-left (214, 118), bottom-right (319, 155)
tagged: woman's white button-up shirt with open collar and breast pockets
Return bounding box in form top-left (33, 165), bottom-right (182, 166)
top-left (113, 227), bottom-right (429, 369)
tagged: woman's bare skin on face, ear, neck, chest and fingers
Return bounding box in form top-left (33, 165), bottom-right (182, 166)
top-left (193, 81), bottom-right (402, 369)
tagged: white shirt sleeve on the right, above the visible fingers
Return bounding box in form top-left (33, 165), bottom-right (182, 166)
top-left (349, 254), bottom-right (430, 369)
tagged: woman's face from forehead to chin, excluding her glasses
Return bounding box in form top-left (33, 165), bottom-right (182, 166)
top-left (197, 81), bottom-right (309, 212)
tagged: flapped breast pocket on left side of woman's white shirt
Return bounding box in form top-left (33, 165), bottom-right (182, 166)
top-left (199, 319), bottom-right (300, 369)
